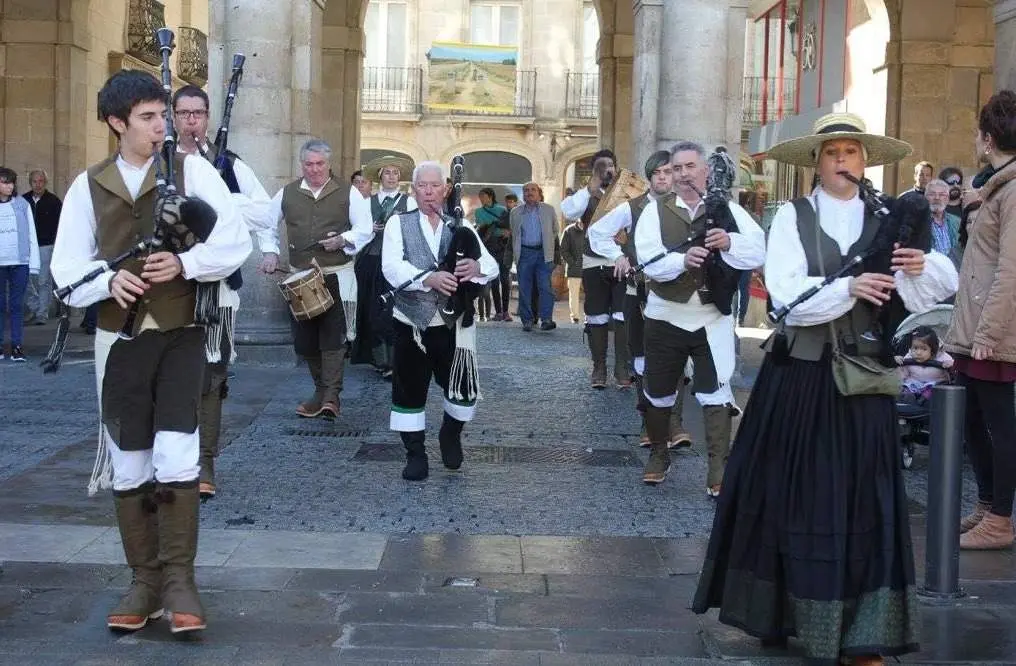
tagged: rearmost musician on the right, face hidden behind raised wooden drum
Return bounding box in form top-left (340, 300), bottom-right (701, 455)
top-left (561, 148), bottom-right (632, 389)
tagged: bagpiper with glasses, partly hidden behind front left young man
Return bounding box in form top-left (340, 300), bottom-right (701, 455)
top-left (173, 85), bottom-right (278, 497)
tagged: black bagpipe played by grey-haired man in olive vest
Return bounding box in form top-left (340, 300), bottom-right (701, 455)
top-left (628, 146), bottom-right (742, 315)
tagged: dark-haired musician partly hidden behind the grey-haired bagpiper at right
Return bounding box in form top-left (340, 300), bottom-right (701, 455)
top-left (587, 150), bottom-right (692, 449)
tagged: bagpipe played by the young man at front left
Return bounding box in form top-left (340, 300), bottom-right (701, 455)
top-left (40, 27), bottom-right (218, 373)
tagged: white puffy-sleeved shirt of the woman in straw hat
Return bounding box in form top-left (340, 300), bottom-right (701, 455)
top-left (765, 188), bottom-right (959, 326)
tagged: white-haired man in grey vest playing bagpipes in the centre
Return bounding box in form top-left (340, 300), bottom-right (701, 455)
top-left (381, 161), bottom-right (500, 481)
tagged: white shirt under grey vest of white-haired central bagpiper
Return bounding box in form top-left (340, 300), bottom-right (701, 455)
top-left (381, 213), bottom-right (501, 326)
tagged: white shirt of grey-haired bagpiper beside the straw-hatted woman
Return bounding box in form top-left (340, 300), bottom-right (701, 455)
top-left (629, 197), bottom-right (765, 332)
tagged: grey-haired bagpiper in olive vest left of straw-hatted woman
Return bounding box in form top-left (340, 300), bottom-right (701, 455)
top-left (635, 141), bottom-right (765, 487)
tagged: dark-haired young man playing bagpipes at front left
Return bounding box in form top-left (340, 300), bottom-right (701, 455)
top-left (53, 69), bottom-right (251, 634)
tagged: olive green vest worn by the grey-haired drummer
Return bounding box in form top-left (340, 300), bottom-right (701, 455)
top-left (282, 179), bottom-right (353, 270)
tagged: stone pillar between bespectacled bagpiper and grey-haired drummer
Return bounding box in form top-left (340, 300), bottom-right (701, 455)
top-left (208, 0), bottom-right (321, 353)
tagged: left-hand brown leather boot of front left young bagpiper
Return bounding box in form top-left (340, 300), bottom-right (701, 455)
top-left (106, 483), bottom-right (163, 631)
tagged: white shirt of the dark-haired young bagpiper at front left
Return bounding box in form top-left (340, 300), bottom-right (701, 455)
top-left (50, 155), bottom-right (252, 308)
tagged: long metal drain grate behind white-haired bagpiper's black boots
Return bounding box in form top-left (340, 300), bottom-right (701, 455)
top-left (353, 444), bottom-right (642, 467)
